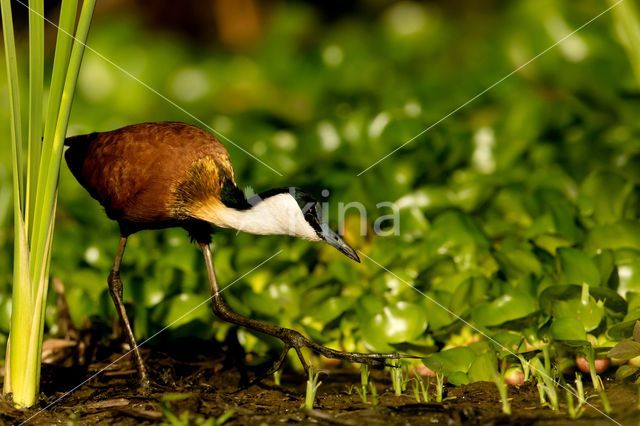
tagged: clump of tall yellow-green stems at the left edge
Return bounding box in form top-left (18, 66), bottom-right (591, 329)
top-left (0, 0), bottom-right (96, 407)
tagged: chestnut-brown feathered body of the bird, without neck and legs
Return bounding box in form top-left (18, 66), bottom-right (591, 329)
top-left (65, 122), bottom-right (234, 225)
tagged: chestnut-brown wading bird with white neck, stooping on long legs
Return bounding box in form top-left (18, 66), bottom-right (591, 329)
top-left (64, 122), bottom-right (401, 390)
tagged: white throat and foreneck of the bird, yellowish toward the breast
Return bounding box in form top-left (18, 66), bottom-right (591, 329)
top-left (198, 193), bottom-right (321, 241)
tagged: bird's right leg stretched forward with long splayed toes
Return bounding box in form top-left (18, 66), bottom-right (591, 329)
top-left (200, 243), bottom-right (413, 380)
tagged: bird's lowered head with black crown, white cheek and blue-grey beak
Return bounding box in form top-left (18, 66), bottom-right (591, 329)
top-left (247, 187), bottom-right (360, 262)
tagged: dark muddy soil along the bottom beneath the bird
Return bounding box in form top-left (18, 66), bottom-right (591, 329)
top-left (0, 342), bottom-right (640, 425)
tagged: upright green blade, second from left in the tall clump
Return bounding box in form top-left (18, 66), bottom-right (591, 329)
top-left (25, 0), bottom-right (44, 240)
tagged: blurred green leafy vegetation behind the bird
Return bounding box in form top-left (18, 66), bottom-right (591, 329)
top-left (0, 0), bottom-right (640, 366)
